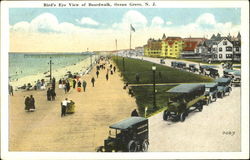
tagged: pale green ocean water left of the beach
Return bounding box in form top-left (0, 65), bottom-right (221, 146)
top-left (9, 53), bottom-right (94, 81)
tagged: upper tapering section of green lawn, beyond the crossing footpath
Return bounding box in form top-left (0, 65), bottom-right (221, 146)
top-left (113, 57), bottom-right (213, 84)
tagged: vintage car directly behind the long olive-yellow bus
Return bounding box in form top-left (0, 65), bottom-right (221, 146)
top-left (204, 83), bottom-right (218, 105)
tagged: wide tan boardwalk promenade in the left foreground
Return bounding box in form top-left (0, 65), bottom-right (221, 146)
top-left (9, 59), bottom-right (137, 152)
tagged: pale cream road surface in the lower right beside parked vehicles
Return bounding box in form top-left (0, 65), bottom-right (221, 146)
top-left (149, 84), bottom-right (241, 152)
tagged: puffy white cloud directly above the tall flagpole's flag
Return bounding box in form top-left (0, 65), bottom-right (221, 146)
top-left (112, 10), bottom-right (148, 30)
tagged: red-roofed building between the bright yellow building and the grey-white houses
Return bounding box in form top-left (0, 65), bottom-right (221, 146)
top-left (181, 37), bottom-right (206, 59)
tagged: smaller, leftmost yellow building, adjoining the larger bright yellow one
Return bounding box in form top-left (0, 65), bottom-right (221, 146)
top-left (144, 38), bottom-right (161, 57)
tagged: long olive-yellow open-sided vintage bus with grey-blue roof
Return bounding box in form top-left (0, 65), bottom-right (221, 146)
top-left (163, 84), bottom-right (205, 122)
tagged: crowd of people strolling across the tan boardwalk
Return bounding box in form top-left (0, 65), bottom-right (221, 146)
top-left (19, 55), bottom-right (139, 117)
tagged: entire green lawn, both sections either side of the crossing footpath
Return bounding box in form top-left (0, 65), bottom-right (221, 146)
top-left (113, 57), bottom-right (213, 116)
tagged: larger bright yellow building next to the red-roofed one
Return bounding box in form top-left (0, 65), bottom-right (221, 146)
top-left (161, 34), bottom-right (184, 58)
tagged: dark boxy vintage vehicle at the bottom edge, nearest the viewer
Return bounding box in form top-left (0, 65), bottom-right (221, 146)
top-left (96, 117), bottom-right (149, 152)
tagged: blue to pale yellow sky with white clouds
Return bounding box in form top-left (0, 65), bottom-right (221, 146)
top-left (9, 8), bottom-right (241, 52)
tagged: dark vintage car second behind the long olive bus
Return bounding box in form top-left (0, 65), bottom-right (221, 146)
top-left (215, 78), bottom-right (232, 98)
